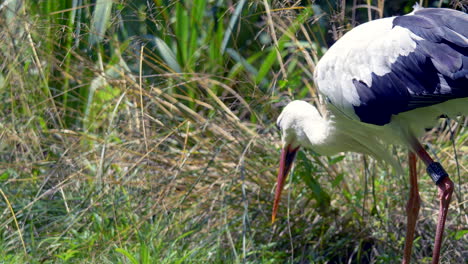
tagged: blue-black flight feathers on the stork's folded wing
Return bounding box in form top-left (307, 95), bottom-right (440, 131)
top-left (353, 8), bottom-right (468, 125)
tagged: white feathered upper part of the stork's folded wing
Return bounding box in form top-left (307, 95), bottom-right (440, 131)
top-left (314, 17), bottom-right (421, 119)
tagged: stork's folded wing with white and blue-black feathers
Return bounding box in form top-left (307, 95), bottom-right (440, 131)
top-left (315, 8), bottom-right (468, 125)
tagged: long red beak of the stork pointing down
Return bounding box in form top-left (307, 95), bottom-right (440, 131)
top-left (271, 145), bottom-right (299, 223)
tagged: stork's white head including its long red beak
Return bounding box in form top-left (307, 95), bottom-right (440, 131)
top-left (271, 101), bottom-right (322, 222)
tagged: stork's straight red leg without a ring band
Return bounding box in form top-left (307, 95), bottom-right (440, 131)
top-left (403, 151), bottom-right (421, 264)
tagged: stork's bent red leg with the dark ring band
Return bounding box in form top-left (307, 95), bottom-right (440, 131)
top-left (412, 139), bottom-right (453, 264)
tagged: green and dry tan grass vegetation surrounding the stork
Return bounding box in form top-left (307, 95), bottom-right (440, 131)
top-left (0, 0), bottom-right (468, 263)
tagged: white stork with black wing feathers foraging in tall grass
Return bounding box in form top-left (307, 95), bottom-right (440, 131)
top-left (272, 6), bottom-right (468, 263)
